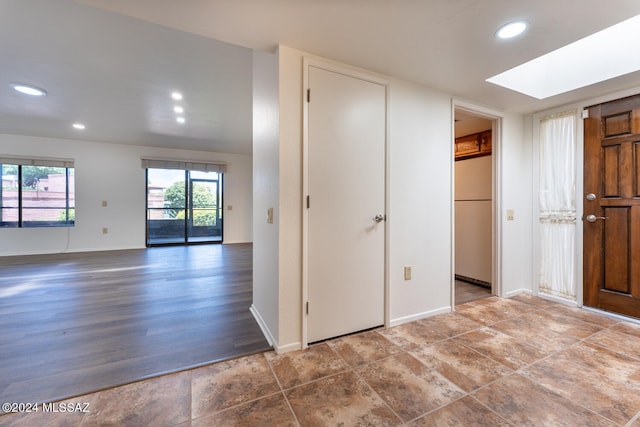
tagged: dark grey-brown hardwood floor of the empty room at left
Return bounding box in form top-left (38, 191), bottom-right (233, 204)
top-left (0, 244), bottom-right (269, 402)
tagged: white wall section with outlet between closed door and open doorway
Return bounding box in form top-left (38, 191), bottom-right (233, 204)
top-left (387, 79), bottom-right (453, 324)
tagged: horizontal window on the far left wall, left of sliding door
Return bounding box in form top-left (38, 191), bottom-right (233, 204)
top-left (0, 158), bottom-right (75, 227)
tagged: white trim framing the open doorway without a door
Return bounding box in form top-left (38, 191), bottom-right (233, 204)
top-left (450, 98), bottom-right (505, 311)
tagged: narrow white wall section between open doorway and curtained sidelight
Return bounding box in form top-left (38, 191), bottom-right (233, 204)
top-left (497, 113), bottom-right (533, 297)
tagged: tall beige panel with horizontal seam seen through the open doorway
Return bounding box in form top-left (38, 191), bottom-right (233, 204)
top-left (454, 156), bottom-right (492, 283)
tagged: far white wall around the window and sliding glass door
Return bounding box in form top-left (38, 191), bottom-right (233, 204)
top-left (0, 134), bottom-right (253, 256)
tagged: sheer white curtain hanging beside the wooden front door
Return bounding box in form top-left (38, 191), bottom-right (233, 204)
top-left (539, 110), bottom-right (577, 300)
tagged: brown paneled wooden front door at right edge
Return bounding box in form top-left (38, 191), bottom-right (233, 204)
top-left (583, 95), bottom-right (640, 318)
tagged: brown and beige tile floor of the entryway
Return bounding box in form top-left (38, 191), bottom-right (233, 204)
top-left (0, 295), bottom-right (640, 427)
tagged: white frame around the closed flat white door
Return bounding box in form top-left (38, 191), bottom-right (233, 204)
top-left (300, 56), bottom-right (390, 349)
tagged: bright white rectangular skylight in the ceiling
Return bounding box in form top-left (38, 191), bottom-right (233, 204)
top-left (486, 15), bottom-right (640, 99)
